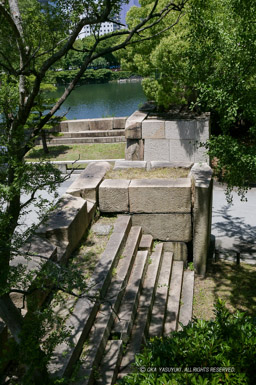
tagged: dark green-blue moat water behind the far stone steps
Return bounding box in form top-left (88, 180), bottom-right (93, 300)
top-left (53, 83), bottom-right (146, 119)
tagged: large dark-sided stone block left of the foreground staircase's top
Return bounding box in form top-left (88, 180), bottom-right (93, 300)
top-left (37, 194), bottom-right (88, 250)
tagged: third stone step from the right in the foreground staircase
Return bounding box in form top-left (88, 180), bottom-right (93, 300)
top-left (149, 252), bottom-right (173, 337)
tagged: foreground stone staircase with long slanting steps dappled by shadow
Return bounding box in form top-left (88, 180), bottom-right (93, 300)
top-left (49, 215), bottom-right (194, 385)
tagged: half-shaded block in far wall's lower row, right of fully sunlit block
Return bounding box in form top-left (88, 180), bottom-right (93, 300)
top-left (170, 139), bottom-right (195, 164)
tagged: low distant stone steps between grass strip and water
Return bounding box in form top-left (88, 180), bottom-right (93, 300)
top-left (48, 129), bottom-right (125, 145)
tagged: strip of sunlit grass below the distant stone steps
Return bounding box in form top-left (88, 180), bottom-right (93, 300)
top-left (26, 143), bottom-right (125, 162)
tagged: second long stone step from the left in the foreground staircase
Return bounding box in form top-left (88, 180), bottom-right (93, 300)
top-left (73, 226), bottom-right (142, 385)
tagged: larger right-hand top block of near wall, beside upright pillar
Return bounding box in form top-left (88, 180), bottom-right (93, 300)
top-left (129, 178), bottom-right (191, 213)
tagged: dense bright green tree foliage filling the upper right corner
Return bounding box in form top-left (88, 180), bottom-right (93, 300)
top-left (121, 0), bottom-right (256, 197)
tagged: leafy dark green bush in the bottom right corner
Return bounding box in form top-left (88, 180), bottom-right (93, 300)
top-left (122, 301), bottom-right (256, 385)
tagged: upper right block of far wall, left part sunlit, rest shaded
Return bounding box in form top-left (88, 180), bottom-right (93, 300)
top-left (165, 119), bottom-right (197, 140)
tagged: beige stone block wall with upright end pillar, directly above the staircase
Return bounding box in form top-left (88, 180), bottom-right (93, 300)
top-left (99, 161), bottom-right (212, 275)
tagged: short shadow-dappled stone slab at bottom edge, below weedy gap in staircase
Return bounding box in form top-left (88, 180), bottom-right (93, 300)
top-left (95, 340), bottom-right (123, 385)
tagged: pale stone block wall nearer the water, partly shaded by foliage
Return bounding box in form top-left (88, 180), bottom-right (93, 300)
top-left (125, 111), bottom-right (210, 166)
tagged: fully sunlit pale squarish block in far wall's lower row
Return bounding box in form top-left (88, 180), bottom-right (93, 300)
top-left (144, 139), bottom-right (170, 162)
